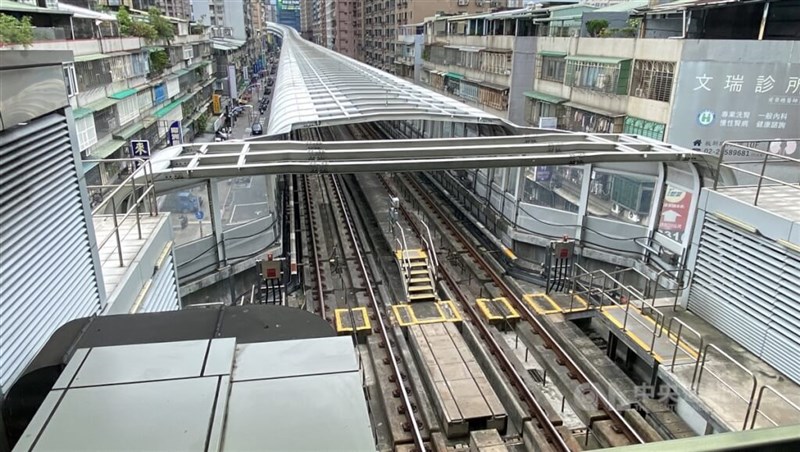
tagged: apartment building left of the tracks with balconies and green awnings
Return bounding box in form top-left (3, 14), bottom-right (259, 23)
top-left (3, 1), bottom-right (214, 185)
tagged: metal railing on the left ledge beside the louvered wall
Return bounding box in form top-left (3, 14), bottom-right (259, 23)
top-left (83, 158), bottom-right (158, 267)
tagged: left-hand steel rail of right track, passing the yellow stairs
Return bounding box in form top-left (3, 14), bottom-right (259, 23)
top-left (379, 176), bottom-right (571, 452)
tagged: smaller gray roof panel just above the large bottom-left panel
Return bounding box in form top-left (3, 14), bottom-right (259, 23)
top-left (71, 340), bottom-right (208, 387)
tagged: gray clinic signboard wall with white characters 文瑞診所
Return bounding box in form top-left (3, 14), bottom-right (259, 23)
top-left (668, 41), bottom-right (800, 161)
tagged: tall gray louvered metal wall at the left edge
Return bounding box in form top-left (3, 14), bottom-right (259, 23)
top-left (0, 113), bottom-right (100, 392)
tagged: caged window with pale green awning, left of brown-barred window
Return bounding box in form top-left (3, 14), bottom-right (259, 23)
top-left (565, 59), bottom-right (630, 94)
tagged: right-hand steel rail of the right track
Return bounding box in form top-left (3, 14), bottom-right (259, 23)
top-left (401, 176), bottom-right (645, 444)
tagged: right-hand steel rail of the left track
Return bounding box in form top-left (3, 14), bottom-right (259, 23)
top-left (332, 176), bottom-right (426, 452)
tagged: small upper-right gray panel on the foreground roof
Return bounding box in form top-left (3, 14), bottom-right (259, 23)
top-left (233, 336), bottom-right (358, 381)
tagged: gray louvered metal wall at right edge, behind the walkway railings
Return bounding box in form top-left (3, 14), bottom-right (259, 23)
top-left (688, 214), bottom-right (800, 383)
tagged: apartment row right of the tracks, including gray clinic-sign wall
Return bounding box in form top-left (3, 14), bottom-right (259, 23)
top-left (421, 1), bottom-right (800, 162)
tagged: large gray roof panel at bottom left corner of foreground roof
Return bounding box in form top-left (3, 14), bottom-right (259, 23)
top-left (33, 378), bottom-right (219, 452)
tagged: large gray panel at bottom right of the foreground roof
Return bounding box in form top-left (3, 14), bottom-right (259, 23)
top-left (223, 372), bottom-right (375, 452)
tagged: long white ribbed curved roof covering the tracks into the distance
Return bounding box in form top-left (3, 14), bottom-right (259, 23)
top-left (266, 23), bottom-right (508, 135)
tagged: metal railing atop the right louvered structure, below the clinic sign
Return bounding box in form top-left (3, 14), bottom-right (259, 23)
top-left (714, 138), bottom-right (800, 206)
